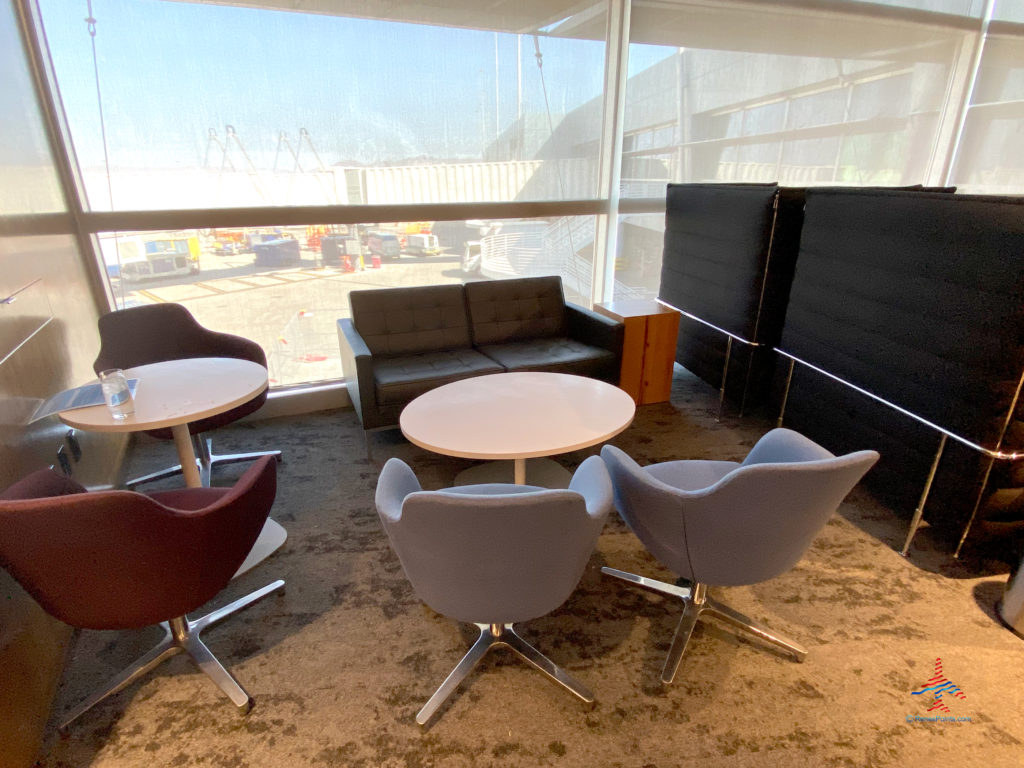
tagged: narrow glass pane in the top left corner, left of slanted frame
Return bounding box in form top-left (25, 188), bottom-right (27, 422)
top-left (0, 3), bottom-right (66, 216)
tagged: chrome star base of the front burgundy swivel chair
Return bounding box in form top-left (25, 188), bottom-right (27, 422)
top-left (59, 579), bottom-right (285, 730)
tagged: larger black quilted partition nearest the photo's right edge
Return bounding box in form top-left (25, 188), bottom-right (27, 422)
top-left (779, 188), bottom-right (1024, 541)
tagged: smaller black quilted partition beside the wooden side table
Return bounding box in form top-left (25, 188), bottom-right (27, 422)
top-left (658, 184), bottom-right (803, 402)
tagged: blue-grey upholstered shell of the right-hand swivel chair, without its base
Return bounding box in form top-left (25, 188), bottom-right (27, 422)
top-left (601, 429), bottom-right (879, 586)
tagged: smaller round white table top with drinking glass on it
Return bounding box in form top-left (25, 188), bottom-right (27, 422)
top-left (59, 357), bottom-right (267, 432)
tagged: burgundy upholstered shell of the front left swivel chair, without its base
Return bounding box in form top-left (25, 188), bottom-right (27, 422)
top-left (0, 457), bottom-right (276, 630)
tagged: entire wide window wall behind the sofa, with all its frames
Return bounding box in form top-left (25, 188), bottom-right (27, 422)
top-left (18, 0), bottom-right (1024, 386)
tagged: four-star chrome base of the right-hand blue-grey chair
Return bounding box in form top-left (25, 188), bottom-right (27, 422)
top-left (601, 567), bottom-right (807, 685)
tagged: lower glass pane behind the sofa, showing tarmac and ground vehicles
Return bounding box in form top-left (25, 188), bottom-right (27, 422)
top-left (99, 216), bottom-right (595, 387)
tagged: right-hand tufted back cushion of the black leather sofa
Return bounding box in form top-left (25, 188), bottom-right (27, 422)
top-left (466, 275), bottom-right (567, 346)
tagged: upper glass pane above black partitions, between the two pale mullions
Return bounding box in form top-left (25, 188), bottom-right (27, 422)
top-left (622, 0), bottom-right (962, 197)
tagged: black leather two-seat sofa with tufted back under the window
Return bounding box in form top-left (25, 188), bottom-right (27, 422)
top-left (338, 276), bottom-right (624, 431)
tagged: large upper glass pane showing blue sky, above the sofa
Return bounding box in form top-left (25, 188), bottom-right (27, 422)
top-left (40, 0), bottom-right (605, 210)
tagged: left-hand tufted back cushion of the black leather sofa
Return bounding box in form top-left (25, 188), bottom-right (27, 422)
top-left (348, 285), bottom-right (471, 356)
